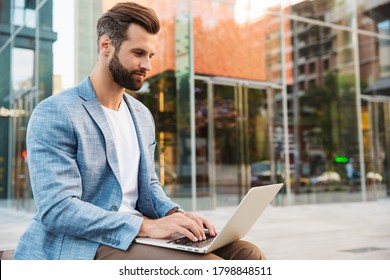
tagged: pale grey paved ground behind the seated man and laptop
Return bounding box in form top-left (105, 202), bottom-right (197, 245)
top-left (0, 199), bottom-right (390, 260)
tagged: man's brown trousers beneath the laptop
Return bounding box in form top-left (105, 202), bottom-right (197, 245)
top-left (95, 240), bottom-right (267, 260)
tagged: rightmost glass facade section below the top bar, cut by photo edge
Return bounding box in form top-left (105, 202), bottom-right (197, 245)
top-left (359, 35), bottom-right (390, 200)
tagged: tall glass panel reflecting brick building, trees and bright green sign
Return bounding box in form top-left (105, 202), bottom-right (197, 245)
top-left (289, 22), bottom-right (361, 203)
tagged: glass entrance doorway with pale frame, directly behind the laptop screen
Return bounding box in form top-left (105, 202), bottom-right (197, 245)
top-left (195, 76), bottom-right (277, 209)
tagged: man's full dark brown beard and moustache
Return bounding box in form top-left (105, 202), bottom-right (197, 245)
top-left (108, 52), bottom-right (145, 91)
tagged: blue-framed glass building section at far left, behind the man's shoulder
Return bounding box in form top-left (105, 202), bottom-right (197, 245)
top-left (0, 0), bottom-right (56, 210)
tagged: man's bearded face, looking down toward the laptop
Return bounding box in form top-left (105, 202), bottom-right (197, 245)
top-left (108, 24), bottom-right (156, 91)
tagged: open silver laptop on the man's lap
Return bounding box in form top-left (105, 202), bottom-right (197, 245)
top-left (135, 184), bottom-right (283, 254)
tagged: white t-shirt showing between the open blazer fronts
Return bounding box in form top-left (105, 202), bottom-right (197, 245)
top-left (102, 101), bottom-right (140, 214)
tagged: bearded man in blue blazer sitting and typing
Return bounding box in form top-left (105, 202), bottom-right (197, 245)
top-left (15, 2), bottom-right (264, 259)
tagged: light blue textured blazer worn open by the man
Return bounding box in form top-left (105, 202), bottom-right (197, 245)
top-left (15, 78), bottom-right (178, 259)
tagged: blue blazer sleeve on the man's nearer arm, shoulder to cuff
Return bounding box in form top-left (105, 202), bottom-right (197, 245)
top-left (27, 98), bottom-right (143, 250)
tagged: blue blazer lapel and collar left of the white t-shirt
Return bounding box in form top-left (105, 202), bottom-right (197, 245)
top-left (79, 78), bottom-right (120, 183)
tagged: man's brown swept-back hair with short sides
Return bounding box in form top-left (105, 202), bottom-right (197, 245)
top-left (96, 2), bottom-right (160, 50)
